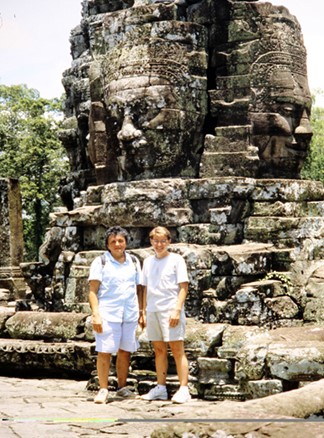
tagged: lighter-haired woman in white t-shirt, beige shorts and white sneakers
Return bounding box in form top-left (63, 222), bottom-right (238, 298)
top-left (142, 227), bottom-right (191, 403)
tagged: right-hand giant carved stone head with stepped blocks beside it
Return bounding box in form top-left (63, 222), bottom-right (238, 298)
top-left (197, 1), bottom-right (311, 178)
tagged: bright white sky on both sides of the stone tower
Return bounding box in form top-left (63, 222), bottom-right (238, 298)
top-left (0, 0), bottom-right (324, 106)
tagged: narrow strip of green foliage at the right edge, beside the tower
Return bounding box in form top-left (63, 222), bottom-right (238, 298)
top-left (301, 91), bottom-right (324, 183)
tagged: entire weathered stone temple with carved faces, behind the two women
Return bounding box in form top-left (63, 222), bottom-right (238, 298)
top-left (0, 0), bottom-right (324, 399)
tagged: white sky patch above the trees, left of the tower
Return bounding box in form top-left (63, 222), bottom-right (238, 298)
top-left (0, 0), bottom-right (81, 99)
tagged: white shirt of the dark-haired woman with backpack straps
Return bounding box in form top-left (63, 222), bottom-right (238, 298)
top-left (88, 251), bottom-right (142, 322)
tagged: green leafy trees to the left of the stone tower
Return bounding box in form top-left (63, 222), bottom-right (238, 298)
top-left (0, 85), bottom-right (68, 260)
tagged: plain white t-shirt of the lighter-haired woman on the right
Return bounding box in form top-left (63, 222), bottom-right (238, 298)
top-left (142, 252), bottom-right (188, 312)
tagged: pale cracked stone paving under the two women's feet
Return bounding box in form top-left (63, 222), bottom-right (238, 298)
top-left (0, 377), bottom-right (215, 438)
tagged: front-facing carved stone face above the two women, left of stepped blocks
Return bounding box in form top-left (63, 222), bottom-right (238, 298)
top-left (105, 80), bottom-right (203, 180)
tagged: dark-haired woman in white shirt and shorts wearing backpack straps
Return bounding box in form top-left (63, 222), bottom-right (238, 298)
top-left (88, 227), bottom-right (142, 403)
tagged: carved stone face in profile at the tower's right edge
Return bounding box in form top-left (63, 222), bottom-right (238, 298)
top-left (251, 66), bottom-right (312, 178)
